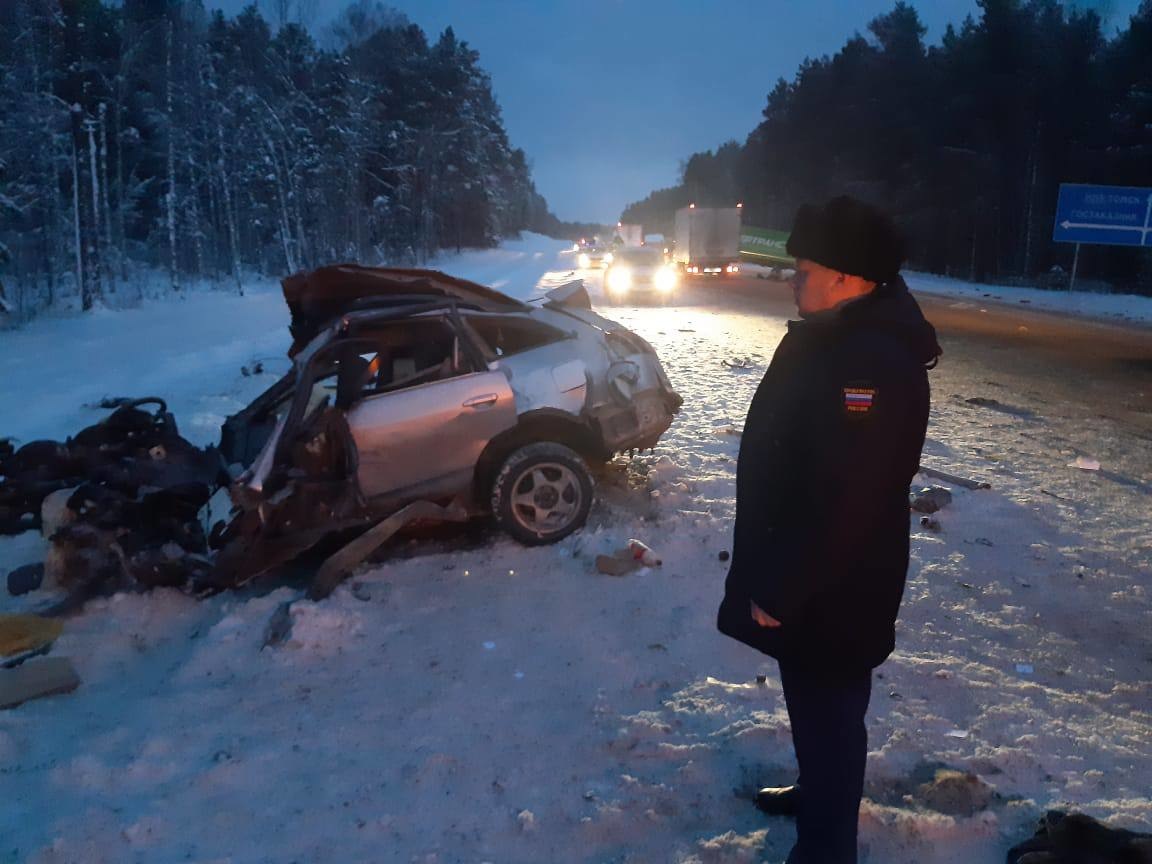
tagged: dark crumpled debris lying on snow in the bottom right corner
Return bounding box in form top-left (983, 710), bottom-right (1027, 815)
top-left (1007, 810), bottom-right (1152, 864)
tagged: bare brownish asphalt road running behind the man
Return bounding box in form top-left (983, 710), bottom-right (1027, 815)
top-left (684, 278), bottom-right (1152, 440)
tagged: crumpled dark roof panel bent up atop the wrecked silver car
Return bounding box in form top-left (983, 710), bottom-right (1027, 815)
top-left (280, 264), bottom-right (529, 356)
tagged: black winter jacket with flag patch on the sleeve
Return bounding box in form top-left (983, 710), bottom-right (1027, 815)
top-left (718, 276), bottom-right (940, 675)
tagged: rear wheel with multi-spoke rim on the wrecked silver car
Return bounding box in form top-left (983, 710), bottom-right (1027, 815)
top-left (492, 441), bottom-right (592, 546)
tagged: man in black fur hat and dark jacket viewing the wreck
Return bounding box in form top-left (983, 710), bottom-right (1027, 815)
top-left (718, 197), bottom-right (940, 864)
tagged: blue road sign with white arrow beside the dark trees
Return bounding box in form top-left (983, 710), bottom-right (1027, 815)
top-left (1052, 183), bottom-right (1152, 247)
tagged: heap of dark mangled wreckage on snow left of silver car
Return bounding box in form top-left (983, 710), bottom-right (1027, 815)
top-left (0, 396), bottom-right (222, 605)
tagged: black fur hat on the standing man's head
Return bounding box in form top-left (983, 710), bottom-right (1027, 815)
top-left (787, 195), bottom-right (905, 282)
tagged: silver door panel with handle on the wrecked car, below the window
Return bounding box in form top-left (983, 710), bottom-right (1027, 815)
top-left (348, 361), bottom-right (516, 499)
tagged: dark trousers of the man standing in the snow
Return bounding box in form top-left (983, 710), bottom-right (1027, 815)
top-left (780, 662), bottom-right (872, 864)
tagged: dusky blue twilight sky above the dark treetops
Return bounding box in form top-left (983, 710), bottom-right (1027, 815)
top-left (206, 0), bottom-right (1138, 222)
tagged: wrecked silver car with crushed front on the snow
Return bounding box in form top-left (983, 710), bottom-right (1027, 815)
top-left (214, 265), bottom-right (682, 584)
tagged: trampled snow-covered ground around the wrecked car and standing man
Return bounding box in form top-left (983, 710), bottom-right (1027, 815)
top-left (0, 237), bottom-right (1152, 864)
